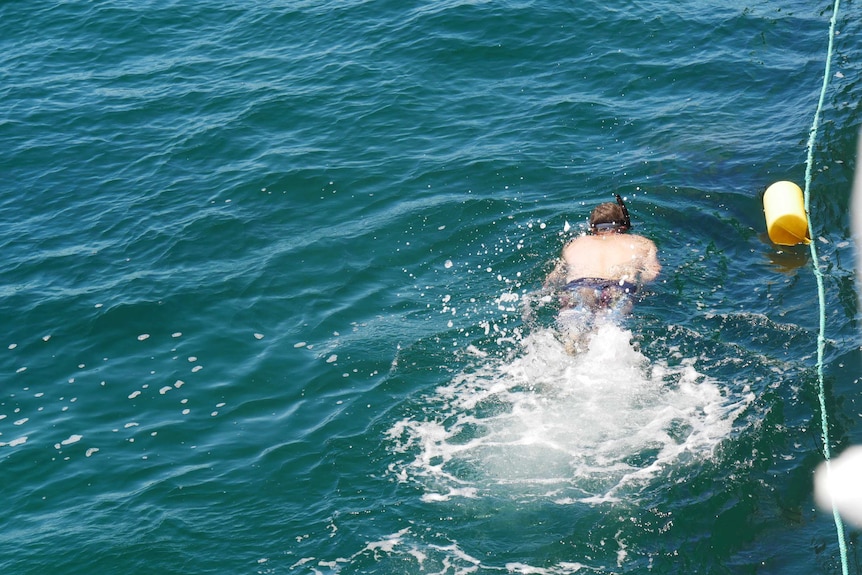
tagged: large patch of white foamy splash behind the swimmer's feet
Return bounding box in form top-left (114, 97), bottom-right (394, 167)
top-left (387, 323), bottom-right (753, 504)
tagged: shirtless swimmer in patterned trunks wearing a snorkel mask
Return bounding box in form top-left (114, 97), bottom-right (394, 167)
top-left (545, 195), bottom-right (661, 352)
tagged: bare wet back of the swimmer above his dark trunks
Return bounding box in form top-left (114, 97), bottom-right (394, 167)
top-left (563, 233), bottom-right (661, 285)
